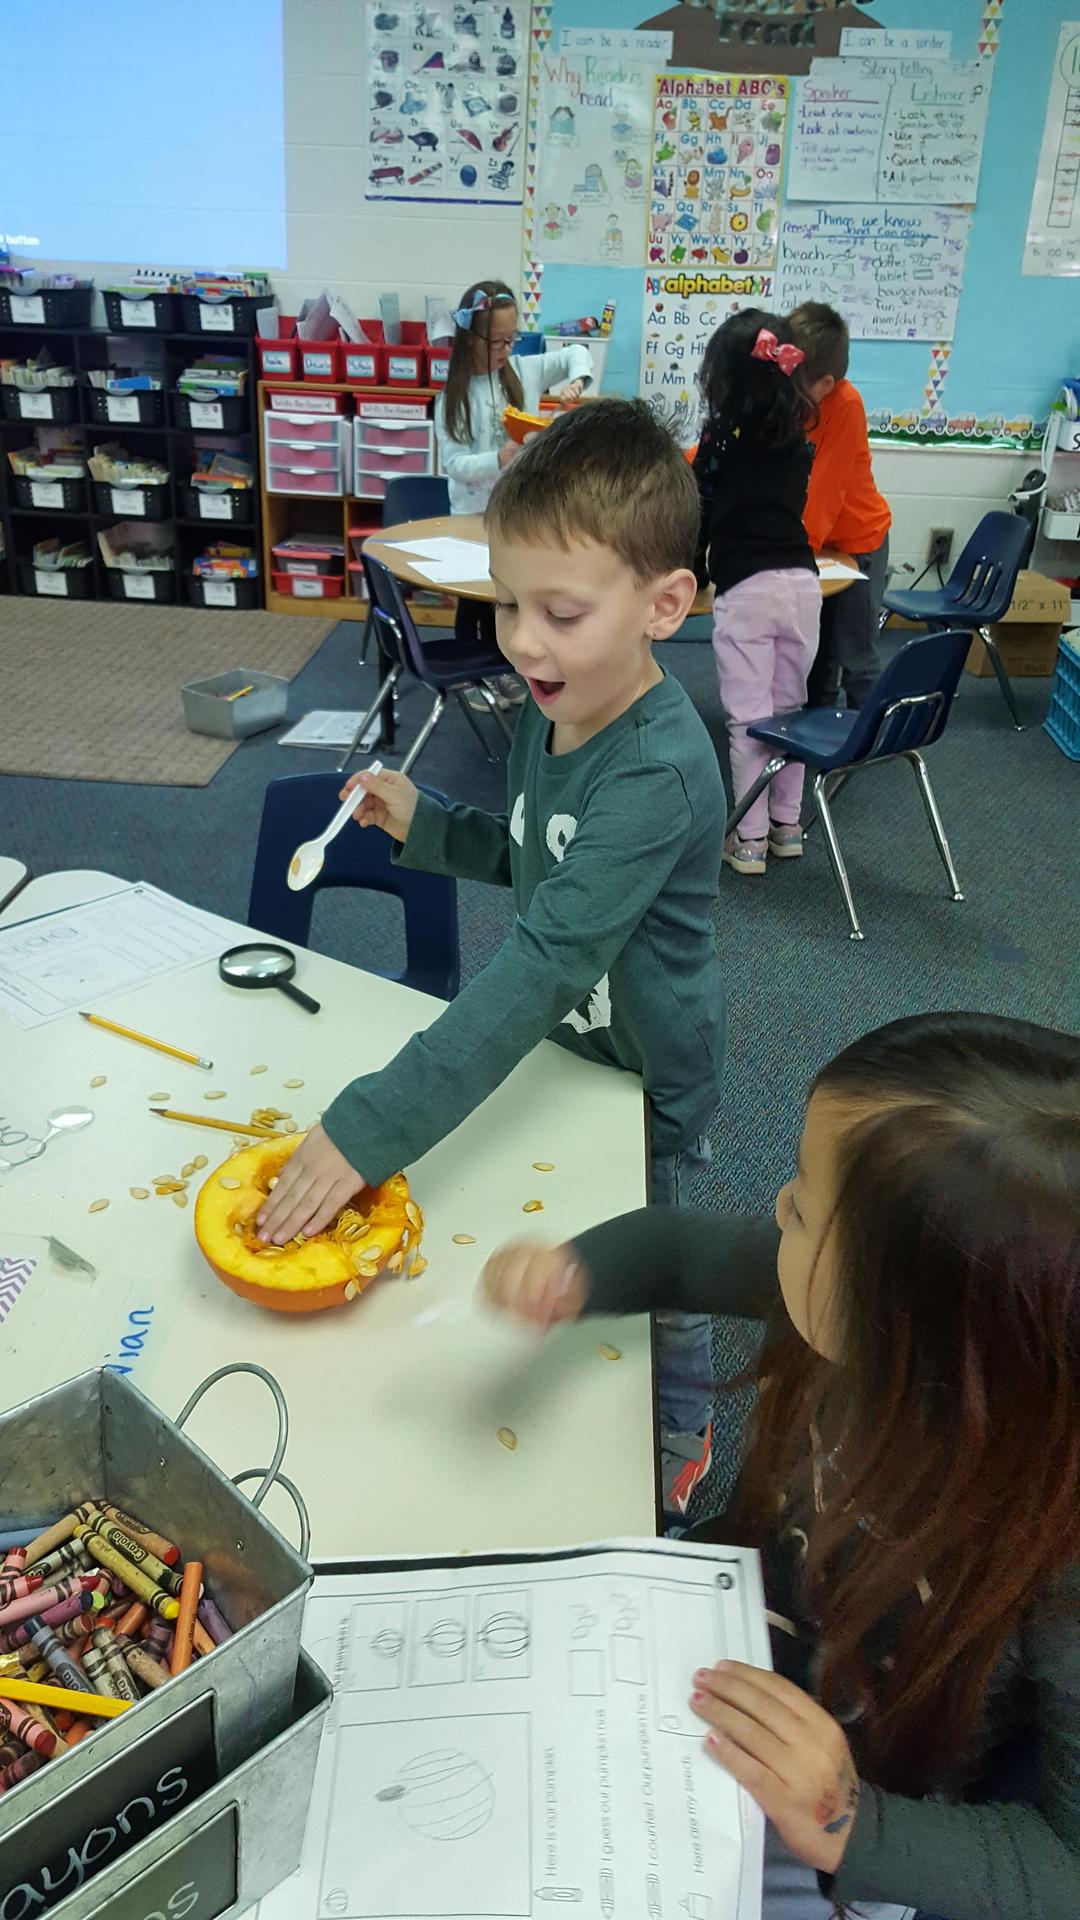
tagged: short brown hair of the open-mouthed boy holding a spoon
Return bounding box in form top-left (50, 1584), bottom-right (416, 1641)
top-left (486, 397), bottom-right (700, 582)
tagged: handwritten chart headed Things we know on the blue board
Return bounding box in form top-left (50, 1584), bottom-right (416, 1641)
top-left (780, 204), bottom-right (969, 342)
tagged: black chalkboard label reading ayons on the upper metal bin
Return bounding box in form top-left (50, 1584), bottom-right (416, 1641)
top-left (0, 1693), bottom-right (216, 1920)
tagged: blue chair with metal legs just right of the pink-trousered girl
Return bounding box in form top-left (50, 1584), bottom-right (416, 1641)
top-left (724, 632), bottom-right (970, 941)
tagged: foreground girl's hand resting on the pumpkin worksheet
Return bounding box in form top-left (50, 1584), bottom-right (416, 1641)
top-left (690, 1661), bottom-right (859, 1874)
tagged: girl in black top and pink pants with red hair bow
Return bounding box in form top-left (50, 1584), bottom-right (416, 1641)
top-left (694, 307), bottom-right (821, 874)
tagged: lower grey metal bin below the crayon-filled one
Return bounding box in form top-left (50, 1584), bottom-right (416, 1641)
top-left (0, 1653), bottom-right (334, 1920)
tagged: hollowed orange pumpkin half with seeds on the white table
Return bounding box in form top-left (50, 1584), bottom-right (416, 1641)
top-left (194, 1133), bottom-right (423, 1313)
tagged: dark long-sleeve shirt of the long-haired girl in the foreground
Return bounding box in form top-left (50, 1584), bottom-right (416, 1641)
top-left (577, 1208), bottom-right (1080, 1920)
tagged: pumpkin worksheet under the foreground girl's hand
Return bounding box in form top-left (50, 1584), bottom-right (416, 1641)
top-left (256, 1540), bottom-right (771, 1920)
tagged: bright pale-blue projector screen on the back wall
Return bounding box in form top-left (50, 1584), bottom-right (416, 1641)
top-left (0, 0), bottom-right (286, 271)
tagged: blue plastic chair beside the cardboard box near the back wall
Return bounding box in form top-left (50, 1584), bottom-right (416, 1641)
top-left (880, 513), bottom-right (1034, 733)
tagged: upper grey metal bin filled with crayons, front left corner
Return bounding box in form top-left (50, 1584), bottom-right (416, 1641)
top-left (0, 1367), bottom-right (313, 1812)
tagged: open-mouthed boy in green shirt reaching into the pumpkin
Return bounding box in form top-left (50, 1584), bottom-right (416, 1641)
top-left (259, 399), bottom-right (724, 1513)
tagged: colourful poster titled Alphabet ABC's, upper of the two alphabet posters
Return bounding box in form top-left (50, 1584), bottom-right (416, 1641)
top-left (648, 73), bottom-right (792, 269)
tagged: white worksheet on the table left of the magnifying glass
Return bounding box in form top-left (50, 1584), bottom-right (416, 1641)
top-left (0, 881), bottom-right (233, 1027)
